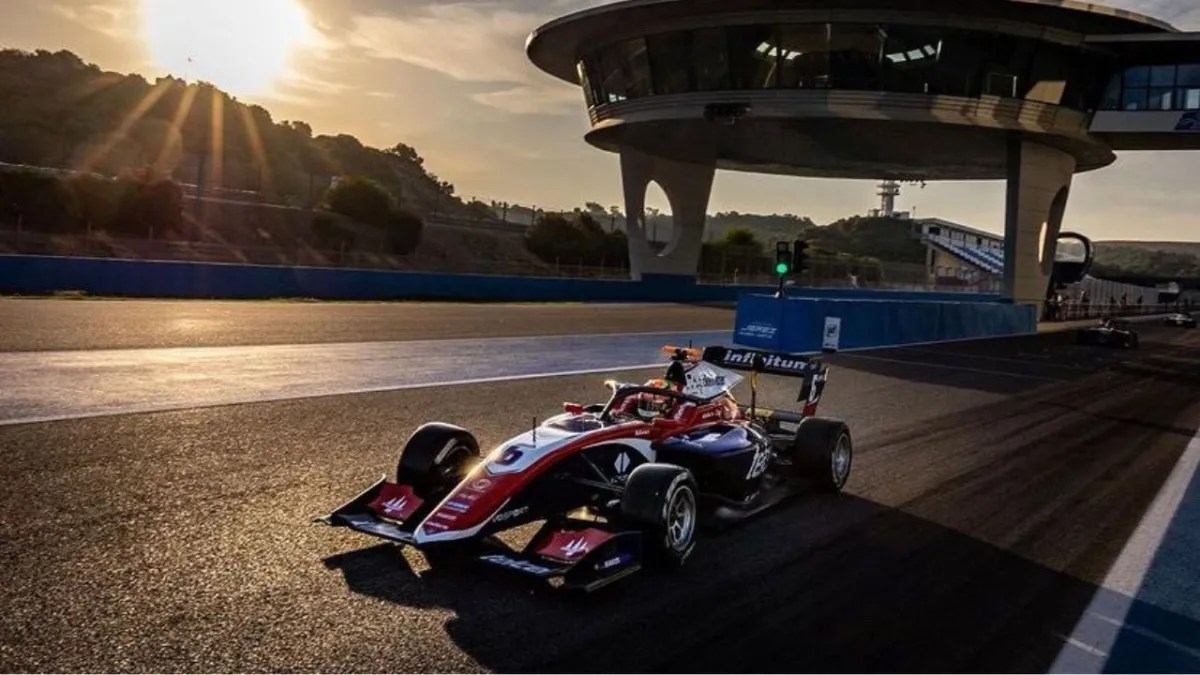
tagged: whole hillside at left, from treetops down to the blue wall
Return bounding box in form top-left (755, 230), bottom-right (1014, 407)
top-left (0, 49), bottom-right (556, 274)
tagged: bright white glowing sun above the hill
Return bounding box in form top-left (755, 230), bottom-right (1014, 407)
top-left (142, 0), bottom-right (313, 95)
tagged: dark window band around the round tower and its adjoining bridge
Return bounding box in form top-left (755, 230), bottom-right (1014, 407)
top-left (581, 23), bottom-right (1200, 110)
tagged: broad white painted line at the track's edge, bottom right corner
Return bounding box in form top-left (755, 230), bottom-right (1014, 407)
top-left (1050, 434), bottom-right (1200, 673)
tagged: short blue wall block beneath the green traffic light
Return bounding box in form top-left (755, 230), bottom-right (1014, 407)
top-left (734, 294), bottom-right (1038, 352)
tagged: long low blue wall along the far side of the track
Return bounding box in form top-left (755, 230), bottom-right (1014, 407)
top-left (0, 255), bottom-right (996, 303)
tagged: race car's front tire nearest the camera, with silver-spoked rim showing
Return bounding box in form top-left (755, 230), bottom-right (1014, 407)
top-left (620, 464), bottom-right (700, 568)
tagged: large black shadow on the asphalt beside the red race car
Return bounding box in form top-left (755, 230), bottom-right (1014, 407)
top-left (330, 487), bottom-right (1200, 673)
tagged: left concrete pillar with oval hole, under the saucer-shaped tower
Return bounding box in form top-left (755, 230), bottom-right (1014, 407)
top-left (620, 148), bottom-right (716, 280)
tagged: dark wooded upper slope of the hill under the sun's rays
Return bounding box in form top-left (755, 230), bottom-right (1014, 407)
top-left (0, 49), bottom-right (472, 216)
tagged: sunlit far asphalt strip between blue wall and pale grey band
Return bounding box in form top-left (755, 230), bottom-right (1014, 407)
top-left (0, 298), bottom-right (730, 352)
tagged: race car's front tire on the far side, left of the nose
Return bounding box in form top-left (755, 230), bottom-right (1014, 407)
top-left (396, 422), bottom-right (479, 497)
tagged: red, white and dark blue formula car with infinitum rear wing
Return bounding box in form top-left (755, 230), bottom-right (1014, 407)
top-left (316, 347), bottom-right (853, 591)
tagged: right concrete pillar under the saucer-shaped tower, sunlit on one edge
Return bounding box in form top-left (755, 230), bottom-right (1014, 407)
top-left (1004, 138), bottom-right (1075, 316)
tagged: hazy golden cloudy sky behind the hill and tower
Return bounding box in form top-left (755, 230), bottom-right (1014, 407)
top-left (0, 0), bottom-right (1200, 241)
